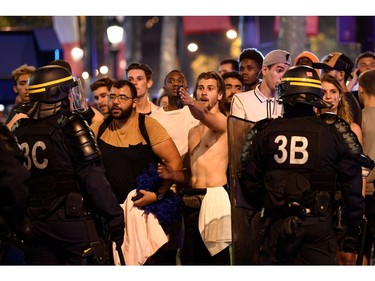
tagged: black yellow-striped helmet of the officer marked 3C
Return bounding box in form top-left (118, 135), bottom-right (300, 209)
top-left (28, 65), bottom-right (76, 103)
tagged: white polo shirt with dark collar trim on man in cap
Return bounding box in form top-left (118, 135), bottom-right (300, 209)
top-left (230, 85), bottom-right (283, 122)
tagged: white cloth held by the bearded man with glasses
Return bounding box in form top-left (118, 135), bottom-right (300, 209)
top-left (112, 189), bottom-right (168, 265)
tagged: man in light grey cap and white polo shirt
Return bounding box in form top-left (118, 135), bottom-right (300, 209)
top-left (231, 49), bottom-right (292, 122)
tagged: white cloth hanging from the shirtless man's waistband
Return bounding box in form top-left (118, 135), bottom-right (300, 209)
top-left (198, 186), bottom-right (232, 256)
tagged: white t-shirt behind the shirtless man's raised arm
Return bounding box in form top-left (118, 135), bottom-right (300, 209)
top-left (150, 106), bottom-right (199, 157)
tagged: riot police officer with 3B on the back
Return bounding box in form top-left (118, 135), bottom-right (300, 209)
top-left (240, 66), bottom-right (373, 264)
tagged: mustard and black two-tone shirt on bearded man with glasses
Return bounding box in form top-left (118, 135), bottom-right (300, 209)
top-left (91, 113), bottom-right (170, 204)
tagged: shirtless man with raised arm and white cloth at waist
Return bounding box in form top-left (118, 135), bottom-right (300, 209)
top-left (158, 71), bottom-right (231, 265)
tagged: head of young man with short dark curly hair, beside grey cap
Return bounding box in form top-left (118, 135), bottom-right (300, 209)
top-left (238, 48), bottom-right (263, 92)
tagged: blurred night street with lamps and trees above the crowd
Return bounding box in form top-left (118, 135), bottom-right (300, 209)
top-left (0, 16), bottom-right (375, 112)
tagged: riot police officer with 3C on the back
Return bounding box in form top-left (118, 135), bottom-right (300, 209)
top-left (12, 65), bottom-right (124, 264)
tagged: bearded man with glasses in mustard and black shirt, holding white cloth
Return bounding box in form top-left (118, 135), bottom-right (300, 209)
top-left (91, 79), bottom-right (182, 265)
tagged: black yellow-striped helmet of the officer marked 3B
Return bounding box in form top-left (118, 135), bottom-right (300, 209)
top-left (278, 65), bottom-right (332, 108)
